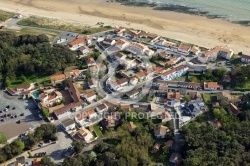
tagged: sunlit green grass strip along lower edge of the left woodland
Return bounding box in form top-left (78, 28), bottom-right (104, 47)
top-left (9, 74), bottom-right (50, 87)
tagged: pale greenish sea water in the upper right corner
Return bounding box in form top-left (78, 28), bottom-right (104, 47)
top-left (155, 0), bottom-right (250, 21)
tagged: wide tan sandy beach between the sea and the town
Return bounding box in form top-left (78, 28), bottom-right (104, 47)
top-left (0, 0), bottom-right (250, 54)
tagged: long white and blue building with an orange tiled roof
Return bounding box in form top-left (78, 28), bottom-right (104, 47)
top-left (161, 65), bottom-right (188, 80)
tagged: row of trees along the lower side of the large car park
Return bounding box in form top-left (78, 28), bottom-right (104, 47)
top-left (0, 124), bottom-right (57, 163)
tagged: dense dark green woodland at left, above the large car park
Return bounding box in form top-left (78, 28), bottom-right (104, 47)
top-left (0, 32), bottom-right (76, 86)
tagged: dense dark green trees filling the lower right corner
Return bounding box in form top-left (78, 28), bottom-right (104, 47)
top-left (181, 109), bottom-right (250, 166)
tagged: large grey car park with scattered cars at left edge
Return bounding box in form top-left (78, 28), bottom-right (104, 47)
top-left (0, 91), bottom-right (43, 139)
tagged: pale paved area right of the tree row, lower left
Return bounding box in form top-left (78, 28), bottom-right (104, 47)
top-left (31, 125), bottom-right (72, 163)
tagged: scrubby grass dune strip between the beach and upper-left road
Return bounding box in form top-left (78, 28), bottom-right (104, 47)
top-left (17, 16), bottom-right (112, 34)
